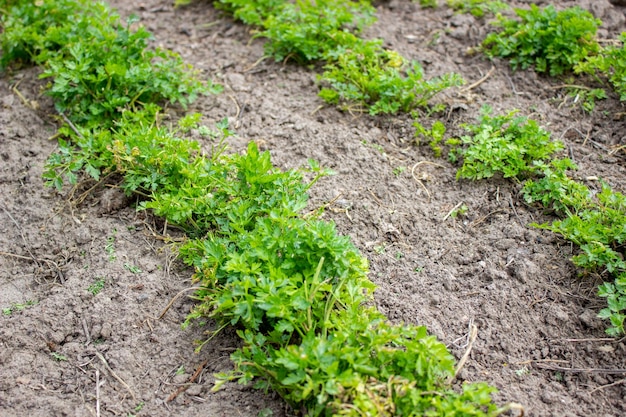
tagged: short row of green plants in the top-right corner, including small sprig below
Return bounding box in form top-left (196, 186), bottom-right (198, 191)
top-left (481, 4), bottom-right (626, 111)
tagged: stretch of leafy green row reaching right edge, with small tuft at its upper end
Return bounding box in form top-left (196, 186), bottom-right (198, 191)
top-left (415, 107), bottom-right (626, 336)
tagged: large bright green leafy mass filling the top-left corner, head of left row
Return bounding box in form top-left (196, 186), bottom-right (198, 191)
top-left (0, 0), bottom-right (218, 126)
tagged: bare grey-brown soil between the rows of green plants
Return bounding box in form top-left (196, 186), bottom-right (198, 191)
top-left (0, 0), bottom-right (626, 417)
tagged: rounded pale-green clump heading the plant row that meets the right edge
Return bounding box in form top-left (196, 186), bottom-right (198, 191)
top-left (450, 107), bottom-right (563, 181)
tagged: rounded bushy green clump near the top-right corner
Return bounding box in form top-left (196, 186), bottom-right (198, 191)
top-left (482, 4), bottom-right (602, 76)
